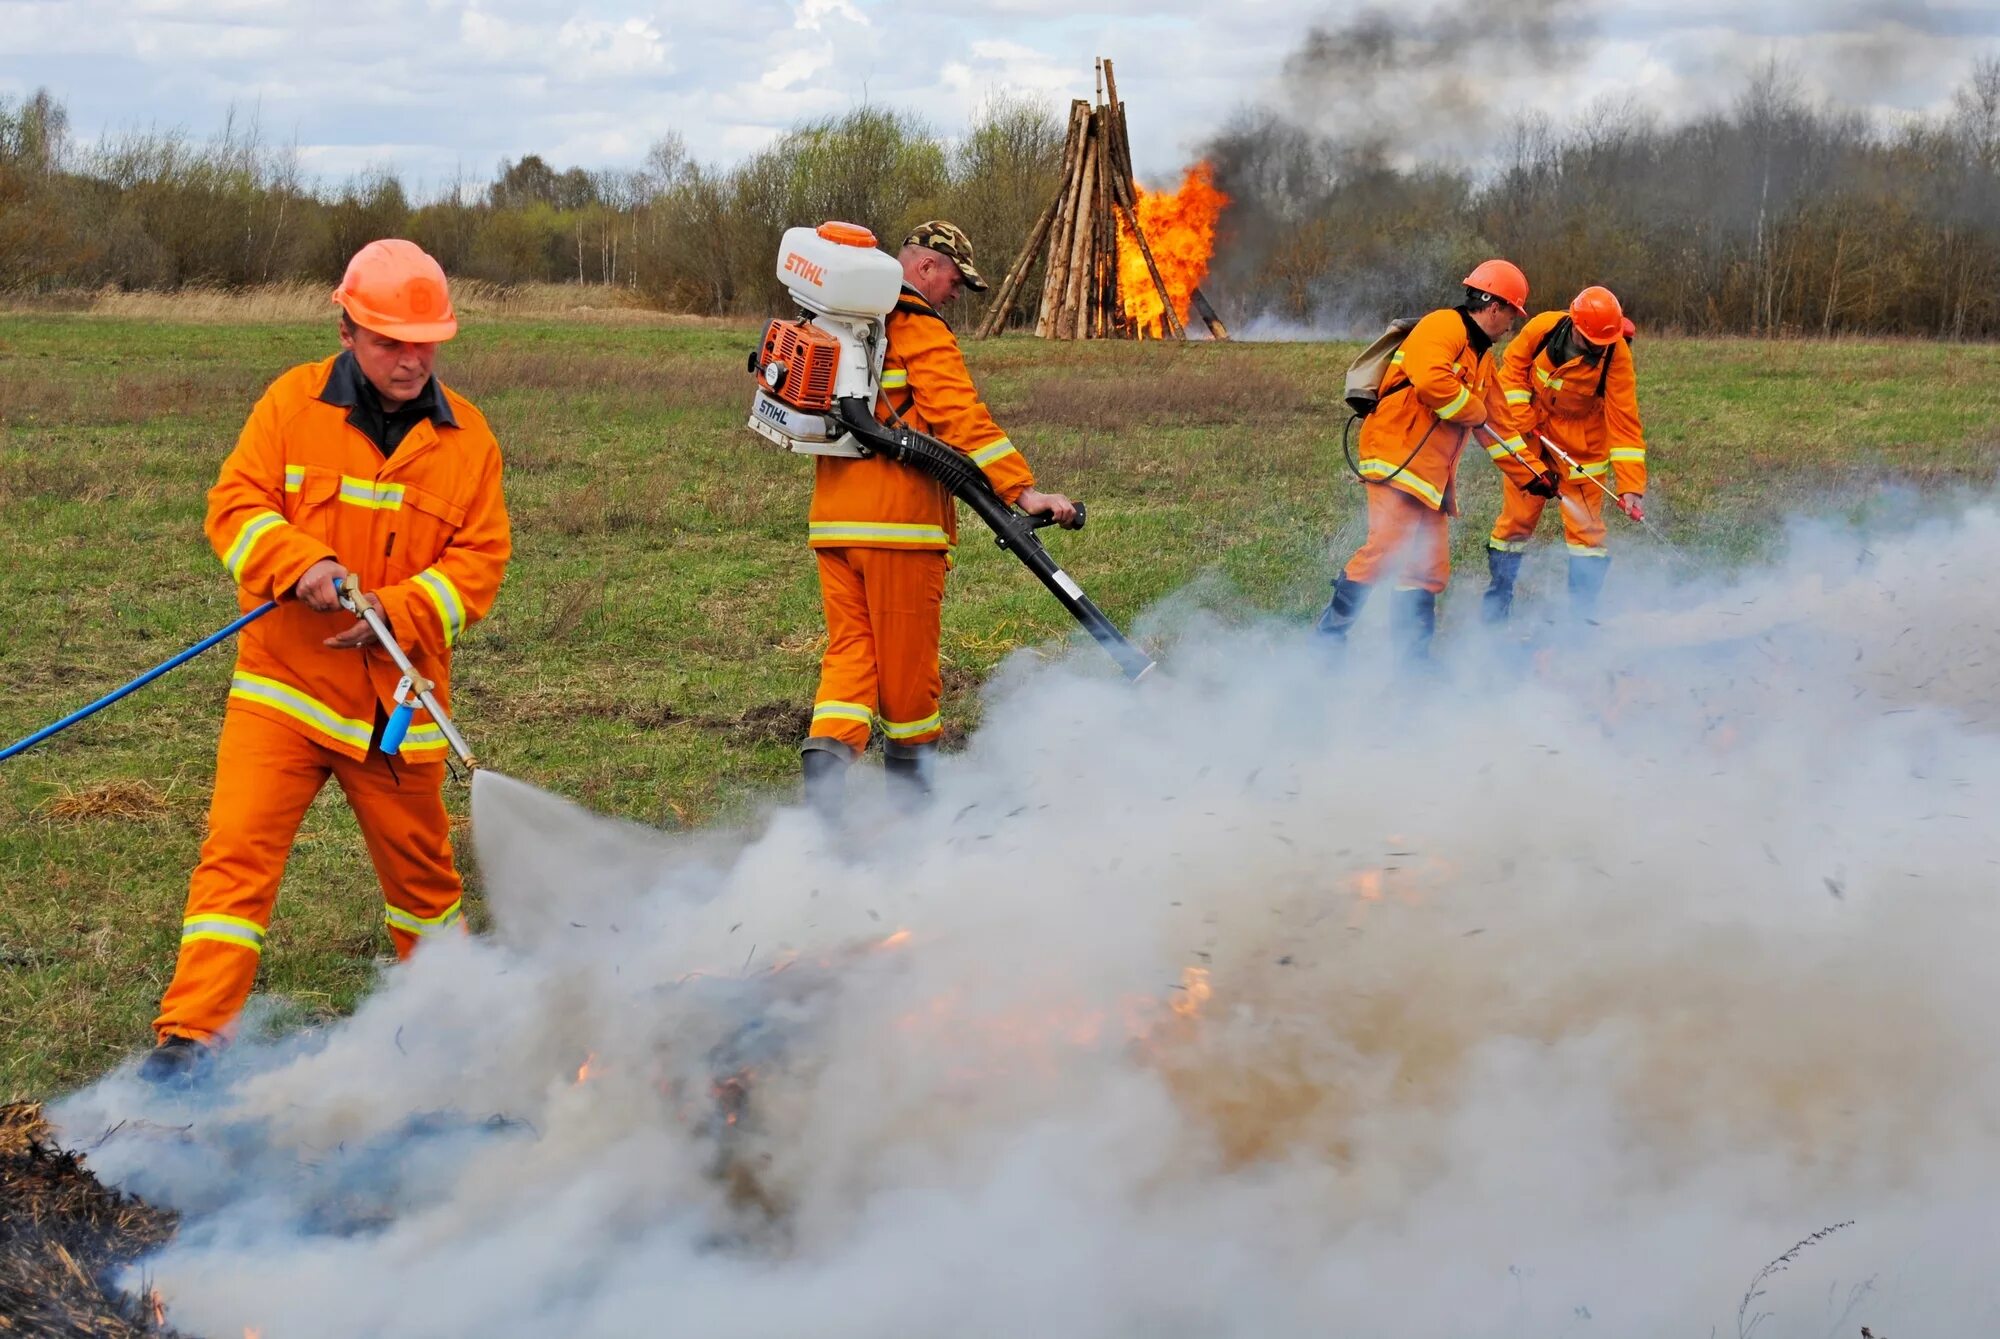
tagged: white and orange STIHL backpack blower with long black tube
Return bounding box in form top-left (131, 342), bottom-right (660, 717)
top-left (750, 224), bottom-right (1152, 681)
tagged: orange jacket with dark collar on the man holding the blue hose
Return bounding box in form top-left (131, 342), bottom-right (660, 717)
top-left (206, 358), bottom-right (512, 761)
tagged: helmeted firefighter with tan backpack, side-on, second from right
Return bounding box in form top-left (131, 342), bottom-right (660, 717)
top-left (1318, 260), bottom-right (1528, 662)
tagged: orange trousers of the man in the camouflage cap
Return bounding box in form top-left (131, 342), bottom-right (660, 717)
top-left (810, 548), bottom-right (950, 753)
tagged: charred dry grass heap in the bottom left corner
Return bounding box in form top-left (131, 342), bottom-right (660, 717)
top-left (0, 1103), bottom-right (186, 1339)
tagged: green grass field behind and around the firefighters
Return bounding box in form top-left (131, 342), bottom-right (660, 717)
top-left (0, 316), bottom-right (2000, 1099)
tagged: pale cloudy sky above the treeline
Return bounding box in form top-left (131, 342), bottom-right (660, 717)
top-left (0, 0), bottom-right (2000, 192)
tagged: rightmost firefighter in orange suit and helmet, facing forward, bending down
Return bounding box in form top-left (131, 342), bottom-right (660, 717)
top-left (1482, 288), bottom-right (1646, 624)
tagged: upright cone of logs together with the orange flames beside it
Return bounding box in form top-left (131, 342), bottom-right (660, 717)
top-left (978, 60), bottom-right (1230, 340)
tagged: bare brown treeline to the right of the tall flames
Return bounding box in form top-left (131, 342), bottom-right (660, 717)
top-left (1210, 60), bottom-right (2000, 340)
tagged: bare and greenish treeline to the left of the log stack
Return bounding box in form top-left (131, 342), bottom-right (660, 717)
top-left (0, 92), bottom-right (1064, 329)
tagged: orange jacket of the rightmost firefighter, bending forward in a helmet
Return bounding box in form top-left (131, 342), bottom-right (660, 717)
top-left (1486, 312), bottom-right (1646, 494)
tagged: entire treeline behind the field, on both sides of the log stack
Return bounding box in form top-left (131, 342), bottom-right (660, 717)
top-left (11, 60), bottom-right (2000, 338)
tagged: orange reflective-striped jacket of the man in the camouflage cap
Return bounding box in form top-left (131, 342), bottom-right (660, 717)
top-left (808, 286), bottom-right (1034, 550)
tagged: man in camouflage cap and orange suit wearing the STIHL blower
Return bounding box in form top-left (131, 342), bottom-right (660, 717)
top-left (800, 220), bottom-right (1076, 813)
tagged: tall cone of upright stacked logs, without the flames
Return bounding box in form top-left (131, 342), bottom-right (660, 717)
top-left (978, 60), bottom-right (1228, 340)
